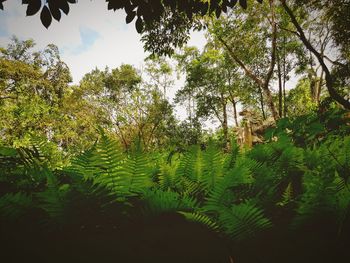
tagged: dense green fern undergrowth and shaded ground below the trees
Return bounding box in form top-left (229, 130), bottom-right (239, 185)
top-left (0, 106), bottom-right (350, 262)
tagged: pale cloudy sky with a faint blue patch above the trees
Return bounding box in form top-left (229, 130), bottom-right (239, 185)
top-left (0, 0), bottom-right (205, 122)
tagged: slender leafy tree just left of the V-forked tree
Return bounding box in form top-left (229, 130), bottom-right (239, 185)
top-left (176, 45), bottom-right (247, 147)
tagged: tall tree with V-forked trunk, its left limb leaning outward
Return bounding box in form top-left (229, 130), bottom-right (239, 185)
top-left (209, 0), bottom-right (279, 120)
